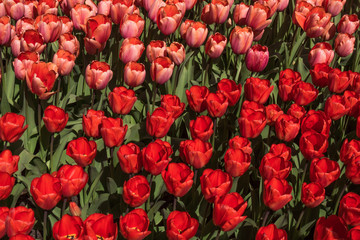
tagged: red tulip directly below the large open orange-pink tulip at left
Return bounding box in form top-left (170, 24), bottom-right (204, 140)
top-left (43, 105), bottom-right (69, 133)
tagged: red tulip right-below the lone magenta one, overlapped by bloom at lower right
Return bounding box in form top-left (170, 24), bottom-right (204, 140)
top-left (279, 68), bottom-right (301, 102)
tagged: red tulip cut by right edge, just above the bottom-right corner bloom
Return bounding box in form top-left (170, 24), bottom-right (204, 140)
top-left (338, 192), bottom-right (360, 226)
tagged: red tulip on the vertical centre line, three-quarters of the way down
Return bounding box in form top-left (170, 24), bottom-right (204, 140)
top-left (161, 163), bottom-right (194, 197)
